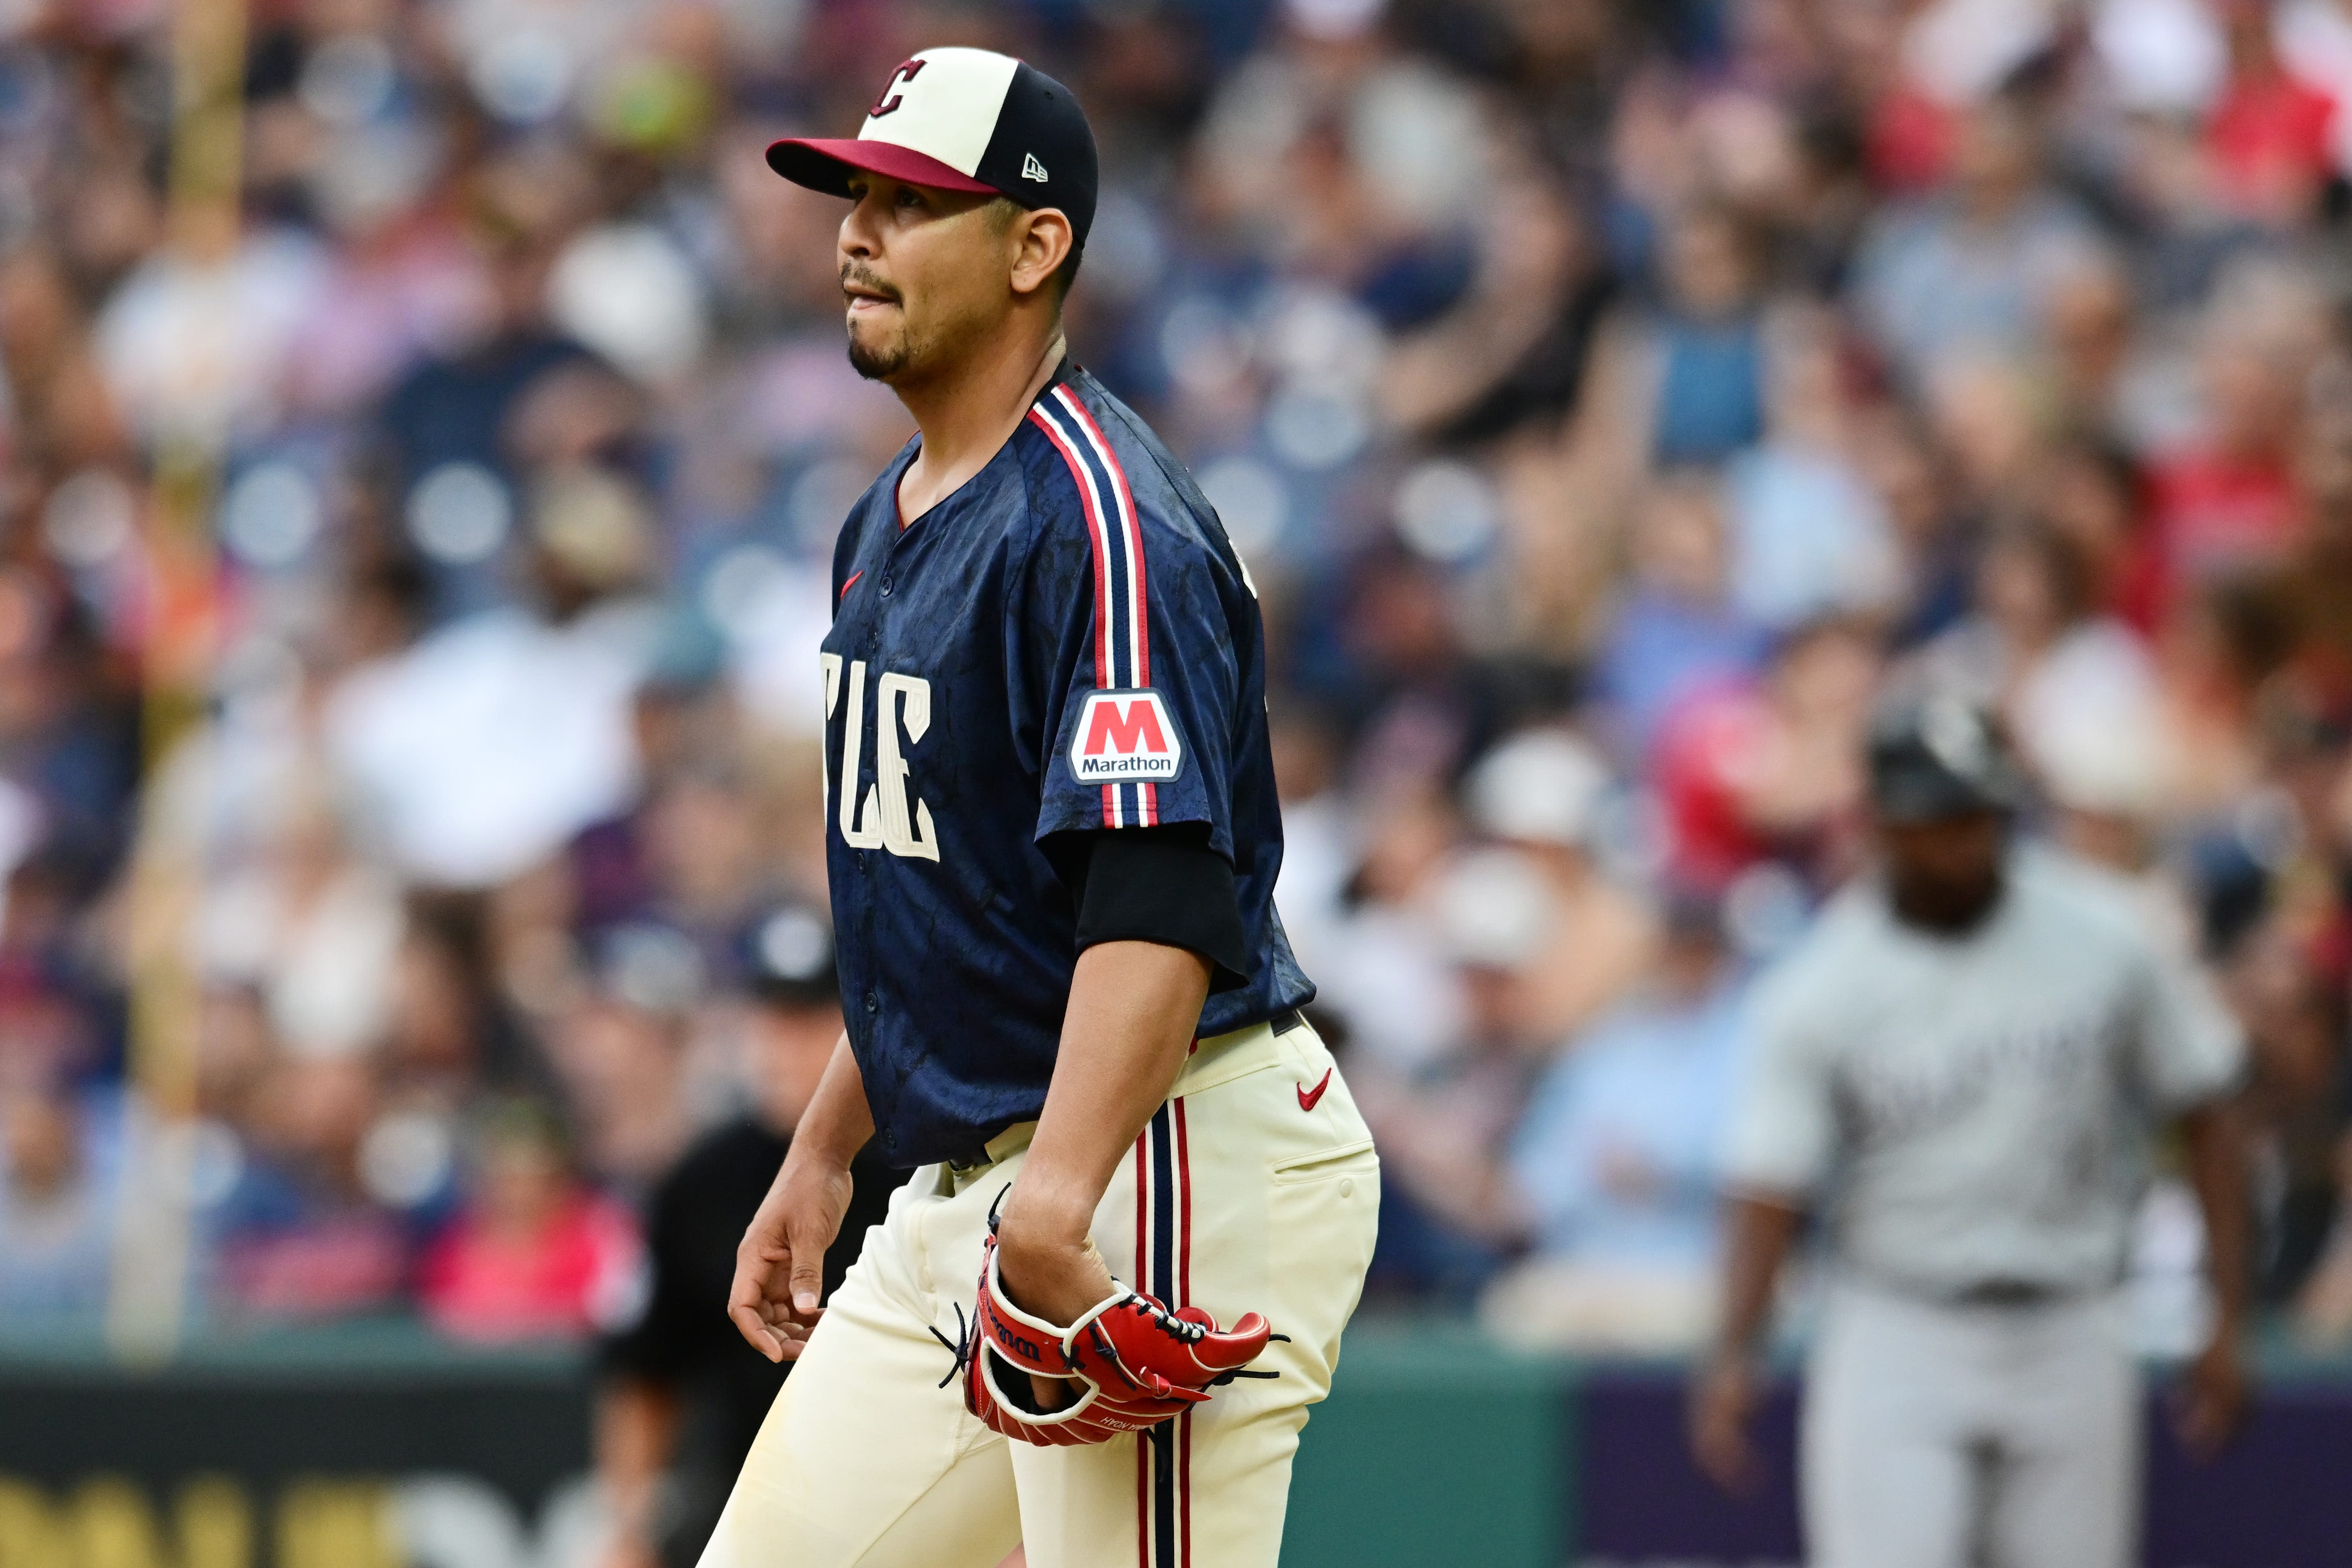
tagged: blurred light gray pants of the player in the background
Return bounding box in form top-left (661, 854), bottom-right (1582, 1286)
top-left (1799, 1284), bottom-right (2140, 1568)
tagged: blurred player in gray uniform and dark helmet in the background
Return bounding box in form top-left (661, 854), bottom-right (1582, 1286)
top-left (1691, 698), bottom-right (2246, 1568)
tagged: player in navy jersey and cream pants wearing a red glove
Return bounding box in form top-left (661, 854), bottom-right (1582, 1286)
top-left (703, 50), bottom-right (1378, 1568)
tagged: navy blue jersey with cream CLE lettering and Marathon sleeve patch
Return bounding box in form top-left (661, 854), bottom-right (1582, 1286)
top-left (823, 367), bottom-right (1315, 1166)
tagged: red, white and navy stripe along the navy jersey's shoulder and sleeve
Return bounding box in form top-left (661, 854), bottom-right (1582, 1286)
top-left (1028, 386), bottom-right (1159, 828)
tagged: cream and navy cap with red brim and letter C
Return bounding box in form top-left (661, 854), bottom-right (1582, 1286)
top-left (767, 50), bottom-right (1096, 245)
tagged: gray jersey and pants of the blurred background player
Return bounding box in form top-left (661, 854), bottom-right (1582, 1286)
top-left (1724, 846), bottom-right (2244, 1568)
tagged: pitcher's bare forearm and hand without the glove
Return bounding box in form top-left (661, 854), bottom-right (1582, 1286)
top-left (727, 1034), bottom-right (875, 1361)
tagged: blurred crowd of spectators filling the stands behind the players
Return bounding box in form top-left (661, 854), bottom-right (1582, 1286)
top-left (0, 0), bottom-right (2352, 1345)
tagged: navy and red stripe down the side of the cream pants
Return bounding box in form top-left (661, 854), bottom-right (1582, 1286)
top-left (1136, 1100), bottom-right (1193, 1568)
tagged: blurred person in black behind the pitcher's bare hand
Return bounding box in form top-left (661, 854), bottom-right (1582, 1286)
top-left (595, 907), bottom-right (906, 1568)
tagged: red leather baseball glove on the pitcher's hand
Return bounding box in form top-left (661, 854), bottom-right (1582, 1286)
top-left (962, 1227), bottom-right (1282, 1446)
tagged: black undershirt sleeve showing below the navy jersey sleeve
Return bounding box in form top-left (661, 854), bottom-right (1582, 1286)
top-left (1051, 823), bottom-right (1249, 992)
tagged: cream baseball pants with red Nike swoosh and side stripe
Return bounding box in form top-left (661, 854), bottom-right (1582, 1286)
top-left (701, 1023), bottom-right (1380, 1568)
